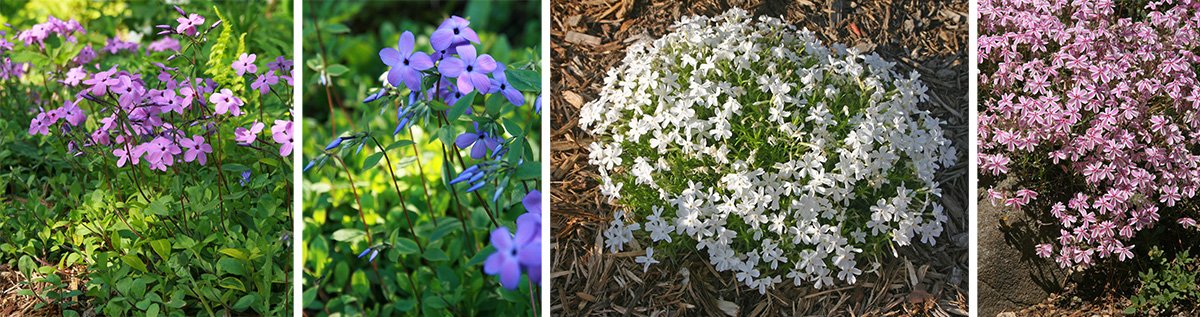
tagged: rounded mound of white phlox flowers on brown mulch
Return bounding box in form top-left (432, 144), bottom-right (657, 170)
top-left (580, 8), bottom-right (956, 293)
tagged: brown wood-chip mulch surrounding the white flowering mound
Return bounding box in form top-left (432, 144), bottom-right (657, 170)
top-left (551, 0), bottom-right (970, 316)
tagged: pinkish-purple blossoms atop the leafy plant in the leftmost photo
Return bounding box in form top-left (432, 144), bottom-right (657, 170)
top-left (17, 7), bottom-right (293, 171)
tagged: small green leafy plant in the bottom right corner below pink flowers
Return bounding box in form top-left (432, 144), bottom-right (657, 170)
top-left (1126, 246), bottom-right (1200, 313)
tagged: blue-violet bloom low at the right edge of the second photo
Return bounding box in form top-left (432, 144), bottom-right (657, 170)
top-left (484, 190), bottom-right (541, 289)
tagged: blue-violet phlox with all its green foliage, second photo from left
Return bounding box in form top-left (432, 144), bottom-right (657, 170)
top-left (302, 2), bottom-right (542, 316)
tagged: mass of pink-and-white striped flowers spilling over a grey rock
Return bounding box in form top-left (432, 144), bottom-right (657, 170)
top-left (977, 0), bottom-right (1200, 268)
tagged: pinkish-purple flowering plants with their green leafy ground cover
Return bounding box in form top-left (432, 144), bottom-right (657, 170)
top-left (0, 1), bottom-right (295, 316)
